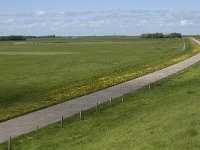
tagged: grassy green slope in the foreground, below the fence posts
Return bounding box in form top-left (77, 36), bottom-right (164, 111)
top-left (0, 49), bottom-right (200, 150)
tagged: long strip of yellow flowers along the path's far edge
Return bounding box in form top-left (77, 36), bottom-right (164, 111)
top-left (0, 37), bottom-right (200, 121)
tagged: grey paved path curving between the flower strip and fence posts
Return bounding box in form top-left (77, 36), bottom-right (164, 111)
top-left (0, 39), bottom-right (200, 143)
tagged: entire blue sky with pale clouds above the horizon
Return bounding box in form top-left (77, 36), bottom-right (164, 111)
top-left (0, 0), bottom-right (200, 35)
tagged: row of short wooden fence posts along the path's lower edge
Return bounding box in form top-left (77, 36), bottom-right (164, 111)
top-left (8, 84), bottom-right (151, 150)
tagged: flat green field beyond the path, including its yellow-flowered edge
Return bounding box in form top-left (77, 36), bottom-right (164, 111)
top-left (0, 37), bottom-right (197, 121)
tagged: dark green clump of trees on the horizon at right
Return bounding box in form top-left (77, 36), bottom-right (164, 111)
top-left (140, 33), bottom-right (182, 38)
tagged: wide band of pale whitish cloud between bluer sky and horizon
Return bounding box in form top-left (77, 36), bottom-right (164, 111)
top-left (0, 10), bottom-right (200, 35)
